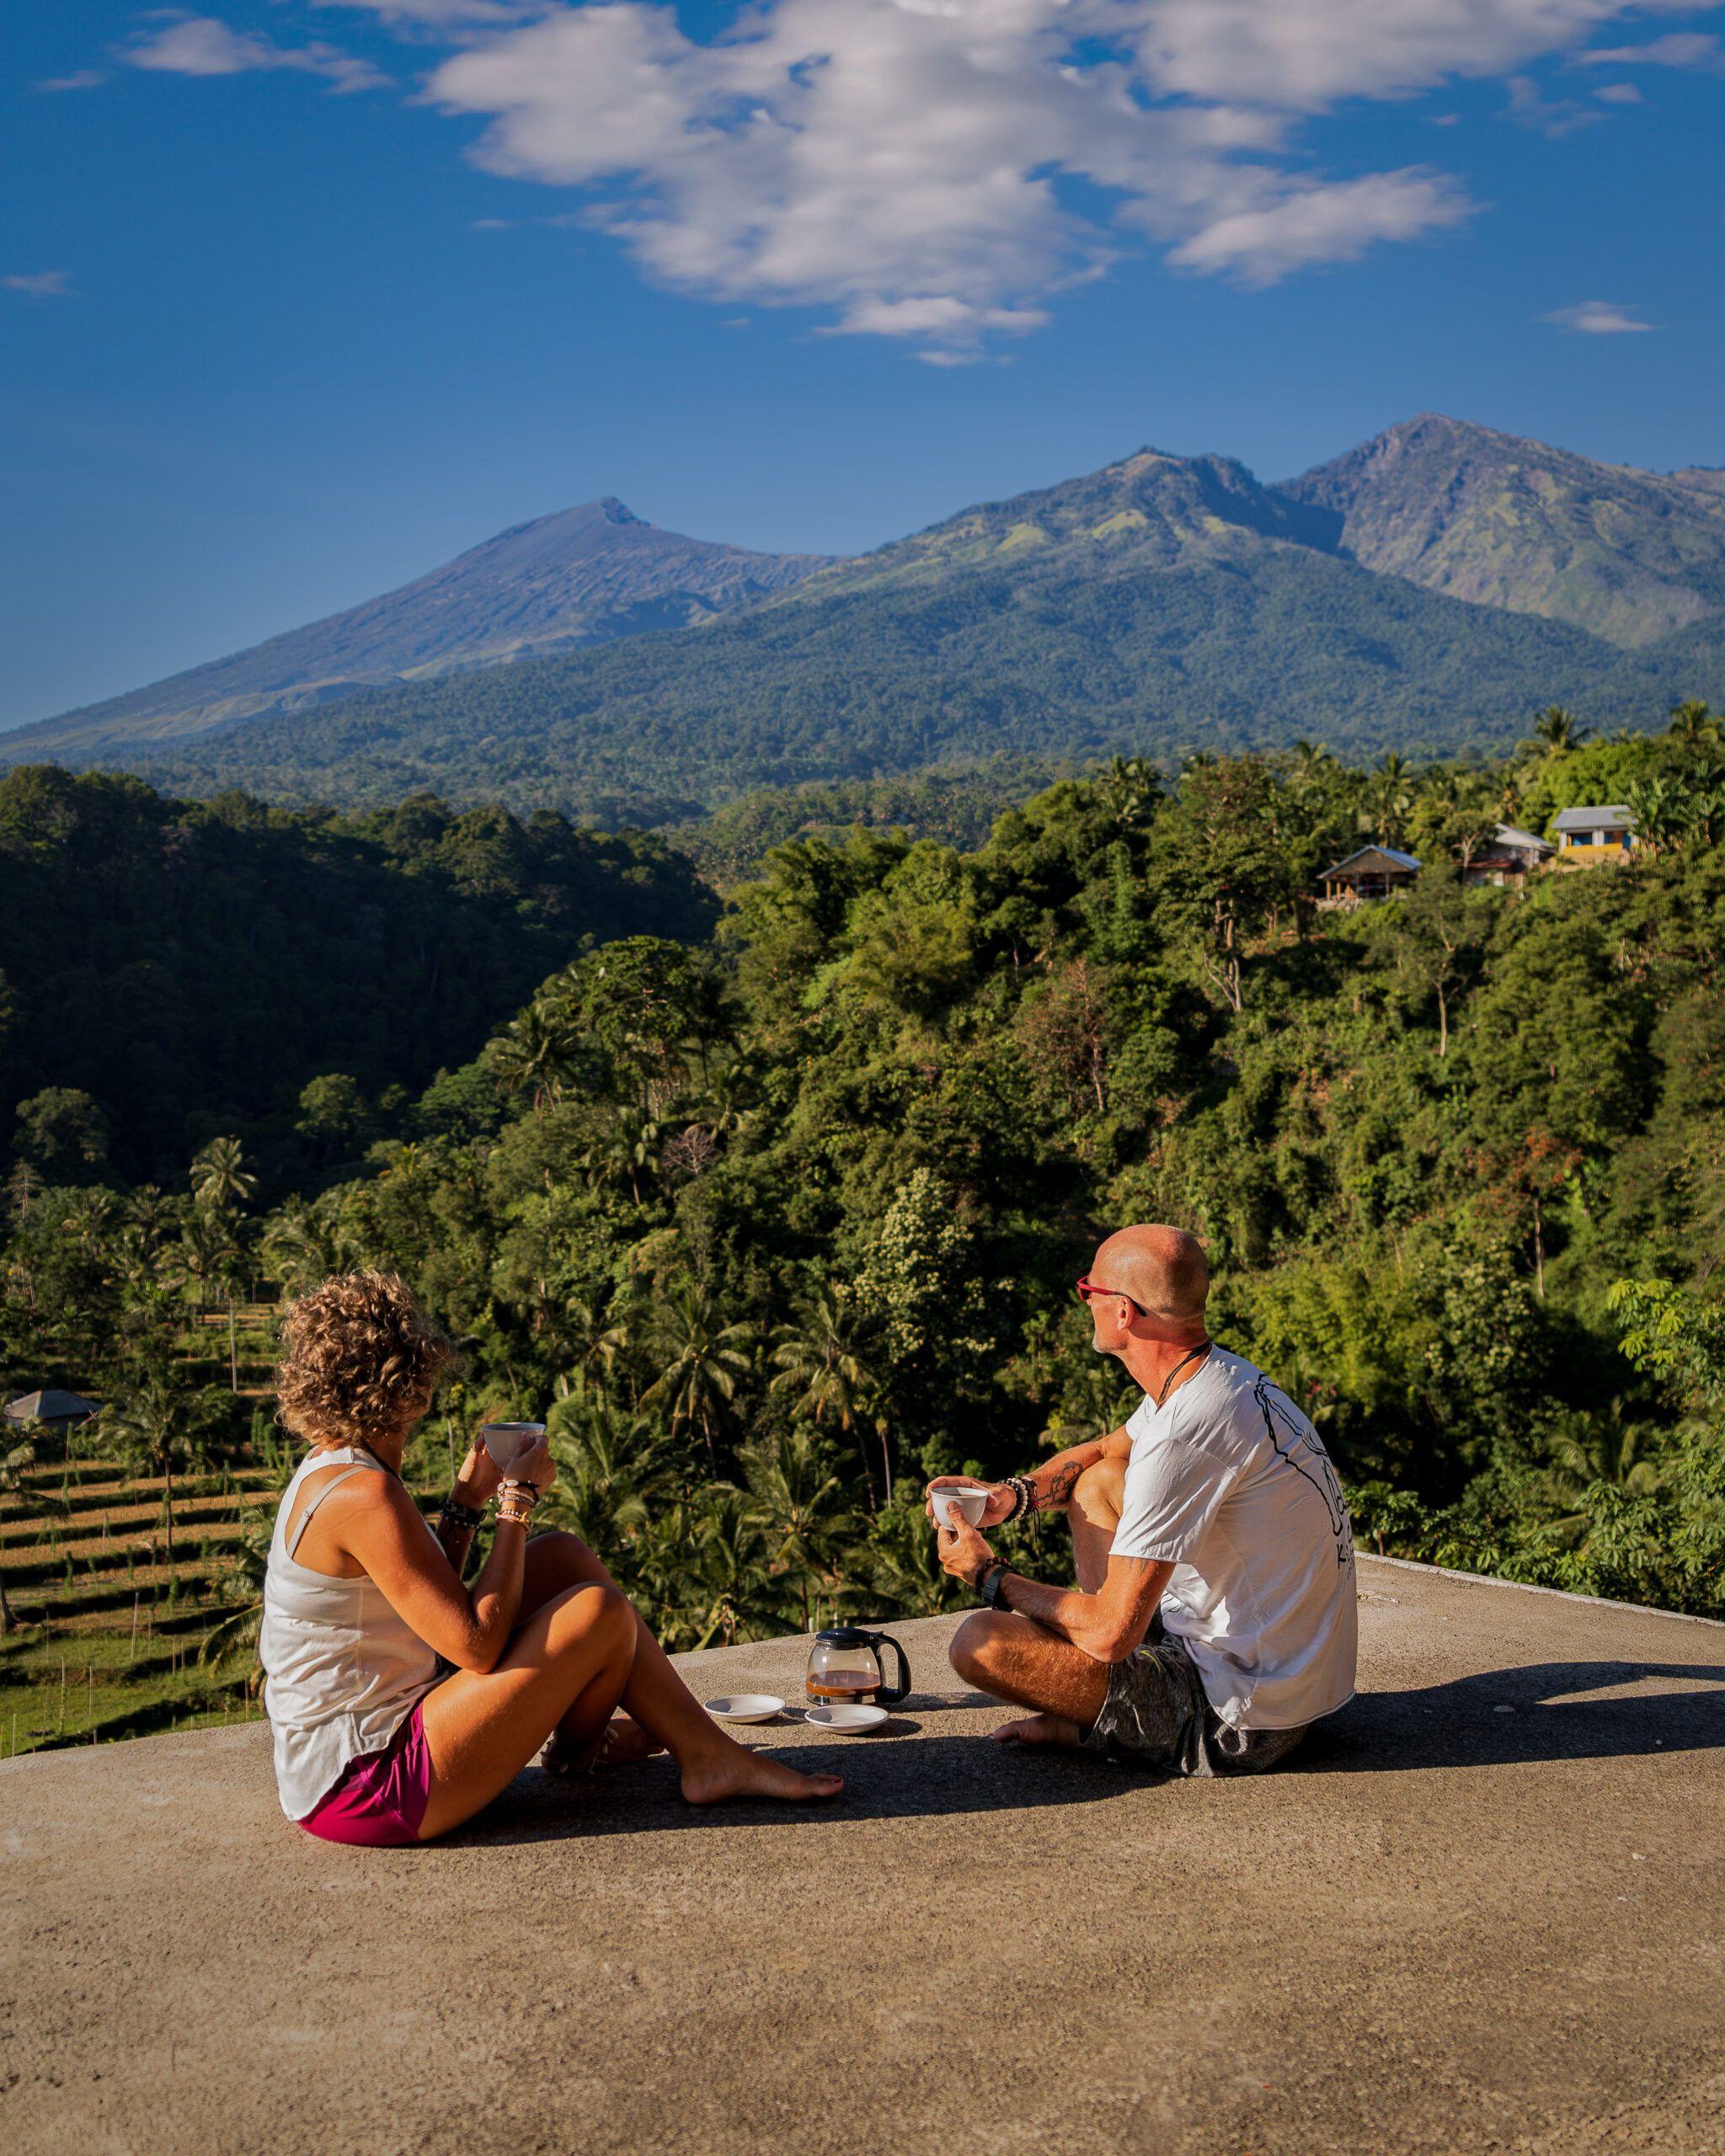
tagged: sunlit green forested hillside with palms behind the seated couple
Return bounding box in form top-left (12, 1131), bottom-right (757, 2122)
top-left (0, 707), bottom-right (1725, 1645)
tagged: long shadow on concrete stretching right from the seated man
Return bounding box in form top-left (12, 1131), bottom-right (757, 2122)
top-left (1311, 1662), bottom-right (1725, 1774)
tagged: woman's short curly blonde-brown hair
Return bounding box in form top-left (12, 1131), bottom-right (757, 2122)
top-left (276, 1272), bottom-right (455, 1444)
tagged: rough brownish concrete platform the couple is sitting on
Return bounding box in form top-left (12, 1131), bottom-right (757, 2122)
top-left (0, 1561), bottom-right (1725, 2156)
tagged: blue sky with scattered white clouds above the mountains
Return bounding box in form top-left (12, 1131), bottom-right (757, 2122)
top-left (0, 0), bottom-right (1725, 724)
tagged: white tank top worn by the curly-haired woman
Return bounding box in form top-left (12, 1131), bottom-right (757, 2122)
top-left (257, 1447), bottom-right (438, 1820)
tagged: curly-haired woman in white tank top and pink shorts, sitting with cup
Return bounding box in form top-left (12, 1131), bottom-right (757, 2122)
top-left (259, 1272), bottom-right (839, 1844)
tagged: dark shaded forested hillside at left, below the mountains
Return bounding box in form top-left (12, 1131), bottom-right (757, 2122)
top-left (0, 766), bottom-right (713, 1186)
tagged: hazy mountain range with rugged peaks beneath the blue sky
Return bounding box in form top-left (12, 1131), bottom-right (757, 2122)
top-left (13, 414), bottom-right (1725, 821)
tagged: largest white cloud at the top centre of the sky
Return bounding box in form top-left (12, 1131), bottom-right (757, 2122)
top-left (427, 0), bottom-right (1518, 351)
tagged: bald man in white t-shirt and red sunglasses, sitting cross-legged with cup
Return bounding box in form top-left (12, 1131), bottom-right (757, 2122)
top-left (929, 1227), bottom-right (1356, 1774)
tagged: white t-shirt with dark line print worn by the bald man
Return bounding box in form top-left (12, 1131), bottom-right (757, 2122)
top-left (1113, 1348), bottom-right (1359, 1729)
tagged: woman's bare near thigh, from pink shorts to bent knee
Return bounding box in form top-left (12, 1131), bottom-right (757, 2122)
top-left (419, 1585), bottom-right (636, 1841)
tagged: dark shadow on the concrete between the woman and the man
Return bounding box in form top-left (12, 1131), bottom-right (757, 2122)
top-left (461, 1716), bottom-right (1132, 1848)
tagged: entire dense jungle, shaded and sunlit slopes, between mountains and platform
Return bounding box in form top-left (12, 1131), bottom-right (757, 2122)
top-left (0, 705), bottom-right (1725, 1647)
